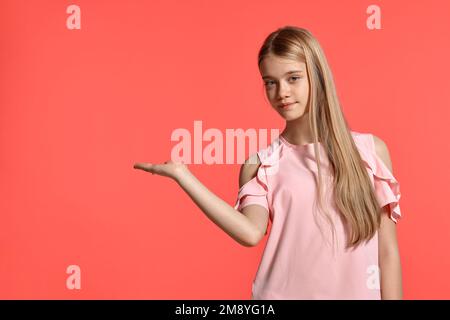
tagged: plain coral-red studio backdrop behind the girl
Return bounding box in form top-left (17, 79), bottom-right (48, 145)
top-left (0, 0), bottom-right (450, 299)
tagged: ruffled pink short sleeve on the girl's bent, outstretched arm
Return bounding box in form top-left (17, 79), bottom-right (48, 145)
top-left (234, 153), bottom-right (269, 211)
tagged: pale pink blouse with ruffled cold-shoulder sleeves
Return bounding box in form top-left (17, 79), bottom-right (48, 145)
top-left (235, 131), bottom-right (401, 300)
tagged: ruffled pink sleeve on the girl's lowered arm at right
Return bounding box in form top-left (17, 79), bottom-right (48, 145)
top-left (361, 134), bottom-right (401, 223)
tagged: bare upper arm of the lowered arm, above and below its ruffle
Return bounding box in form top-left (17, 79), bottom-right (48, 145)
top-left (373, 136), bottom-right (398, 256)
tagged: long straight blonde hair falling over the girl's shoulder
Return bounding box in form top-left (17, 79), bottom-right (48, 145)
top-left (258, 26), bottom-right (381, 247)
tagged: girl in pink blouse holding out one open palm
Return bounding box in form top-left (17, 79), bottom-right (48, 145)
top-left (134, 26), bottom-right (402, 299)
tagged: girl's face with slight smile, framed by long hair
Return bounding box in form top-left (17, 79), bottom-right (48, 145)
top-left (259, 55), bottom-right (309, 121)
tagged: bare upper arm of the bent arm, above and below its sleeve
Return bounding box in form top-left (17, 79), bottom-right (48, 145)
top-left (239, 154), bottom-right (269, 242)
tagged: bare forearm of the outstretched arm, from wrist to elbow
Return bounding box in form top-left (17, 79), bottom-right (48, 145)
top-left (176, 170), bottom-right (260, 246)
